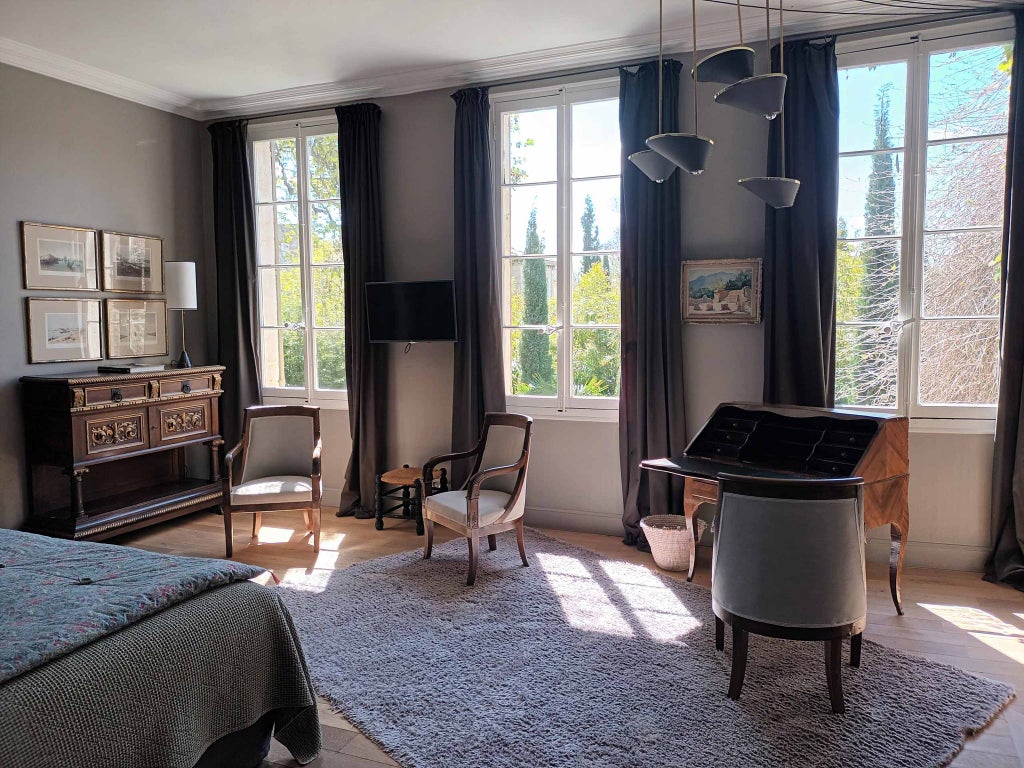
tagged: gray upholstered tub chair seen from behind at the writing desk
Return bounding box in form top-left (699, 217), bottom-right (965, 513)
top-left (712, 475), bottom-right (867, 715)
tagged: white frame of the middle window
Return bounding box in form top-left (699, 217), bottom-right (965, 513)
top-left (490, 78), bottom-right (622, 421)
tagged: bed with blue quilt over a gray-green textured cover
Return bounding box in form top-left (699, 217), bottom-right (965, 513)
top-left (0, 530), bottom-right (321, 768)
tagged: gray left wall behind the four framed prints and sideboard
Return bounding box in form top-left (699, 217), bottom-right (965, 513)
top-left (0, 65), bottom-right (209, 527)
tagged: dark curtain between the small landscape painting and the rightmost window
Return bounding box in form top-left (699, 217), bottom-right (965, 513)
top-left (764, 39), bottom-right (839, 408)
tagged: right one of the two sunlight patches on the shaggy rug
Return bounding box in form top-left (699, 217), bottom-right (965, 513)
top-left (601, 560), bottom-right (700, 642)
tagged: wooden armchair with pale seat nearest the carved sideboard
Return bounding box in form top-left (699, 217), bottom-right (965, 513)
top-left (221, 406), bottom-right (322, 557)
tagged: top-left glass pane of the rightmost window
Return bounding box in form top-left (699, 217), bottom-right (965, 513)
top-left (839, 61), bottom-right (906, 152)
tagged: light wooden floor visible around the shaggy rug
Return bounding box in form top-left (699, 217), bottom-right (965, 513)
top-left (115, 510), bottom-right (1024, 768)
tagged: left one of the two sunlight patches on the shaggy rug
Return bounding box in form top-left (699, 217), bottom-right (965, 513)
top-left (535, 552), bottom-right (633, 637)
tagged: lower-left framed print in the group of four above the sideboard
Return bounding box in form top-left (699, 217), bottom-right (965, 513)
top-left (26, 298), bottom-right (102, 362)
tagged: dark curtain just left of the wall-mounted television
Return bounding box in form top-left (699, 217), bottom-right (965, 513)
top-left (336, 103), bottom-right (387, 516)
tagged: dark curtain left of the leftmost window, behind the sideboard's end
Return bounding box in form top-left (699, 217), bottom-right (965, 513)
top-left (209, 120), bottom-right (260, 447)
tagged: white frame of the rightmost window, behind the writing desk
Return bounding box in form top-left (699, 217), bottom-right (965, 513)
top-left (837, 15), bottom-right (1014, 433)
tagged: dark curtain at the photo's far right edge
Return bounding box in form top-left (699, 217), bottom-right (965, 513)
top-left (985, 10), bottom-right (1024, 590)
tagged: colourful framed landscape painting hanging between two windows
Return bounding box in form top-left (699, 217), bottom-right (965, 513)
top-left (680, 259), bottom-right (761, 325)
